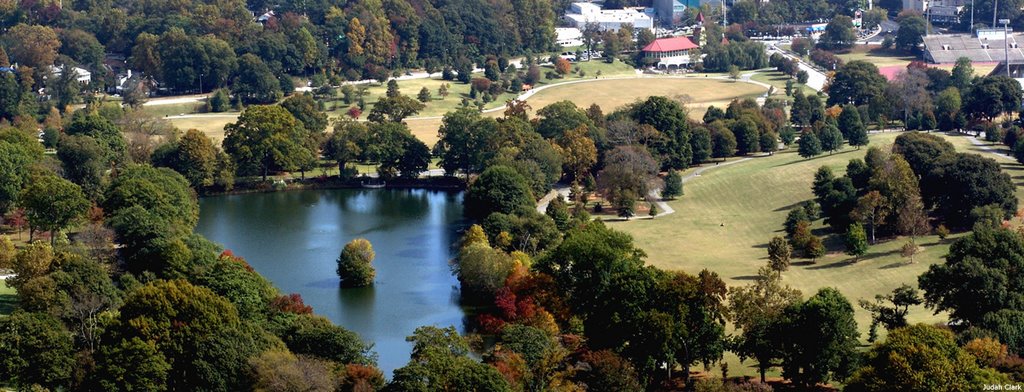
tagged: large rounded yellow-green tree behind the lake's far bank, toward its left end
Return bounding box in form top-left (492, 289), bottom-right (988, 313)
top-left (224, 105), bottom-right (311, 181)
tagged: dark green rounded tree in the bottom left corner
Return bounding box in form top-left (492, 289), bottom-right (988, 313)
top-left (0, 311), bottom-right (75, 389)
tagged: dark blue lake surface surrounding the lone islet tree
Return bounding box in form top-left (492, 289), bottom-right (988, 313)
top-left (197, 189), bottom-right (466, 378)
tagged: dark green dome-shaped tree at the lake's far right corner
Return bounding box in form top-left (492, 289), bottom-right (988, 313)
top-left (464, 166), bottom-right (536, 219)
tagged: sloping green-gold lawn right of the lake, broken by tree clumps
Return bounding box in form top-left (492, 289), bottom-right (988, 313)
top-left (612, 133), bottom-right (1024, 352)
